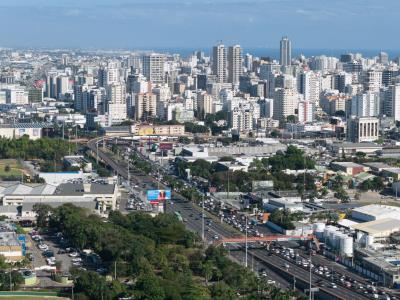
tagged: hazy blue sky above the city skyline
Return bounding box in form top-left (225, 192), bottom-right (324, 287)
top-left (0, 0), bottom-right (400, 53)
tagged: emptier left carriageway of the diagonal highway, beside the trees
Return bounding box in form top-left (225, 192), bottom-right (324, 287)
top-left (87, 138), bottom-right (370, 300)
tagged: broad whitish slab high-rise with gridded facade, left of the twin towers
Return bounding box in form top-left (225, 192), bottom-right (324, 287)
top-left (143, 53), bottom-right (165, 84)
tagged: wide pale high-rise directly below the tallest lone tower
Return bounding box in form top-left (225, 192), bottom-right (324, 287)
top-left (274, 88), bottom-right (300, 120)
